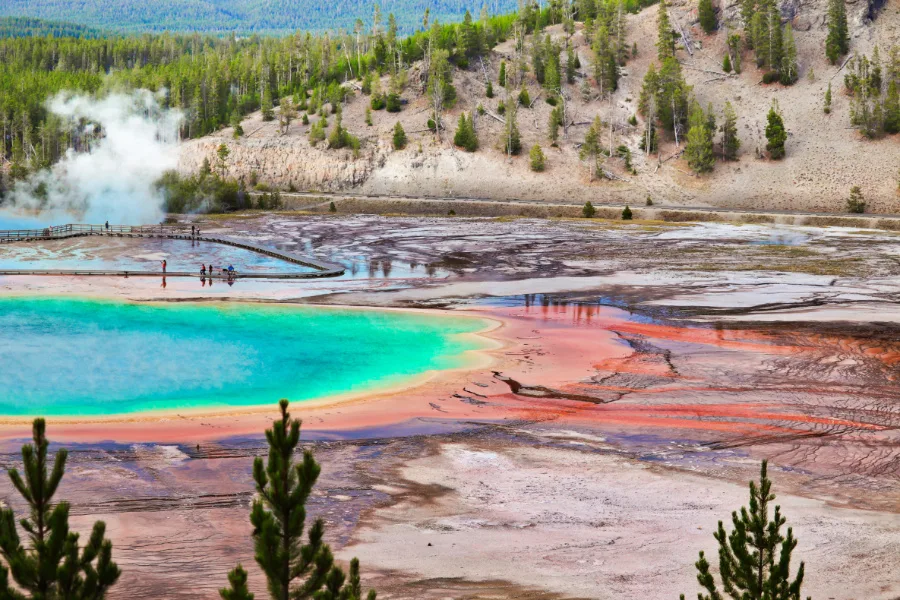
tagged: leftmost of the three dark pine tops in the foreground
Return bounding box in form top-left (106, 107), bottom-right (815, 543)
top-left (0, 419), bottom-right (121, 600)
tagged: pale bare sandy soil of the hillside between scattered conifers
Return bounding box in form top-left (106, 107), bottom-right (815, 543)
top-left (182, 0), bottom-right (900, 212)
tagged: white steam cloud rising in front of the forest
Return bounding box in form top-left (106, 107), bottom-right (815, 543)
top-left (10, 90), bottom-right (183, 224)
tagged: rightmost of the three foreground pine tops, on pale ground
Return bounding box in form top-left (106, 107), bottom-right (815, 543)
top-left (681, 461), bottom-right (804, 600)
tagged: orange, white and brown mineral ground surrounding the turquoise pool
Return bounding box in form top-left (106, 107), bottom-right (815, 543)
top-left (0, 215), bottom-right (900, 600)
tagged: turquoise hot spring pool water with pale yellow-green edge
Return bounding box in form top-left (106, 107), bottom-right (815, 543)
top-left (0, 298), bottom-right (492, 416)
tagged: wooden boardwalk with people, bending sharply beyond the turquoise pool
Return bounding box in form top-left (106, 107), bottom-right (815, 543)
top-left (0, 224), bottom-right (344, 279)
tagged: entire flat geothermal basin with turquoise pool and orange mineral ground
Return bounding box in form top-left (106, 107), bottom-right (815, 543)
top-left (0, 207), bottom-right (900, 600)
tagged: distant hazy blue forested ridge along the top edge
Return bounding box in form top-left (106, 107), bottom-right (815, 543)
top-left (0, 0), bottom-right (517, 34)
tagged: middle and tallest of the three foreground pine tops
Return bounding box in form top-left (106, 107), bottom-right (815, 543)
top-left (219, 400), bottom-right (375, 600)
